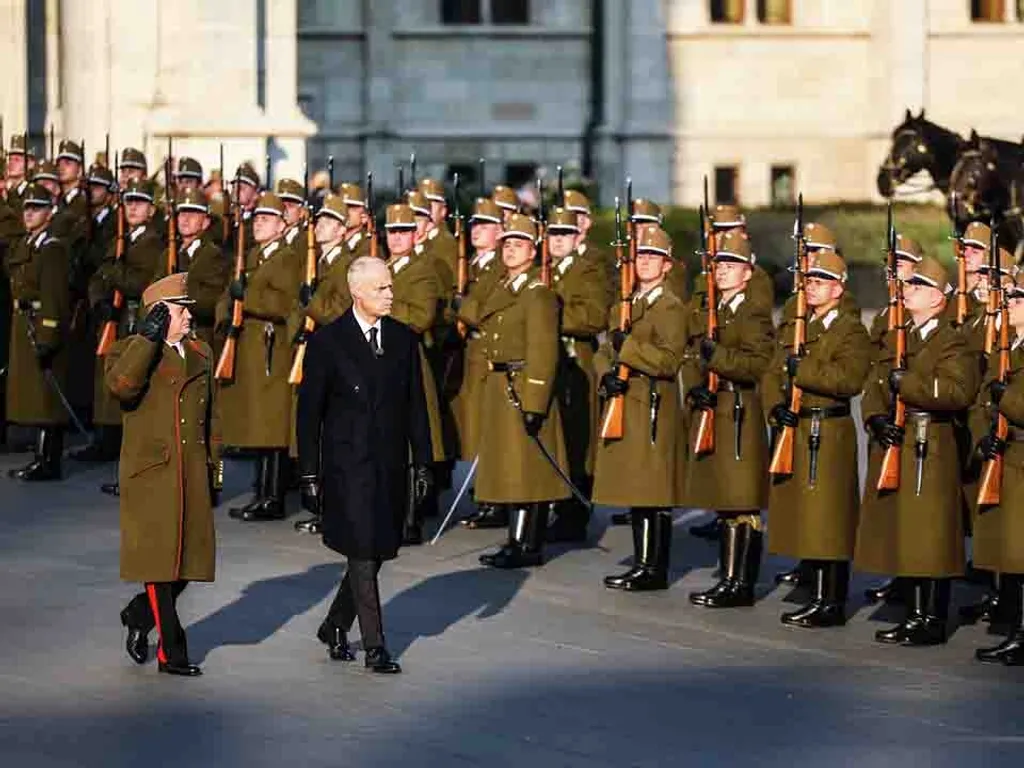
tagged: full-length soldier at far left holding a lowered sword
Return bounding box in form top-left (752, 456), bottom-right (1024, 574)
top-left (4, 183), bottom-right (70, 481)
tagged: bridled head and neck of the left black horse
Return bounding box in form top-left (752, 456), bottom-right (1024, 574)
top-left (878, 110), bottom-right (965, 198)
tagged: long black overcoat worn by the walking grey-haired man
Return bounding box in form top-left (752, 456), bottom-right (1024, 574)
top-left (296, 309), bottom-right (431, 560)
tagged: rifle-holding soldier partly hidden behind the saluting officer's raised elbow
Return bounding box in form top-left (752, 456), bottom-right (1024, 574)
top-left (87, 178), bottom-right (165, 483)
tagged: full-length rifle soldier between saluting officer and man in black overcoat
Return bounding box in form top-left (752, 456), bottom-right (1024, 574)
top-left (217, 192), bottom-right (302, 521)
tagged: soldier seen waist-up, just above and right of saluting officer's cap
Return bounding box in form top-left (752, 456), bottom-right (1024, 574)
top-left (174, 189), bottom-right (231, 351)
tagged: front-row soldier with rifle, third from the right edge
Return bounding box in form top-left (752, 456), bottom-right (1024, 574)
top-left (761, 249), bottom-right (872, 628)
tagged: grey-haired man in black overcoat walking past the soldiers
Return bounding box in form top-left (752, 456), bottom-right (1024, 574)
top-left (296, 256), bottom-right (431, 673)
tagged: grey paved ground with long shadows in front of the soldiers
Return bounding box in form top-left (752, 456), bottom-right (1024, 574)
top-left (0, 455), bottom-right (1024, 768)
